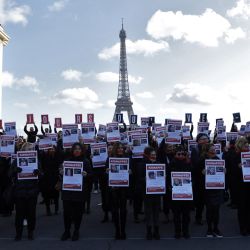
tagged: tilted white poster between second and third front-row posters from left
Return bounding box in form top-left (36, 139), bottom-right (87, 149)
top-left (90, 142), bottom-right (108, 168)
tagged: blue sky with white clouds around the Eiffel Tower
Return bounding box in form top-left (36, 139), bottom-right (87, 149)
top-left (0, 0), bottom-right (250, 135)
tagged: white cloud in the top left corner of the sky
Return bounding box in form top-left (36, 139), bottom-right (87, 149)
top-left (0, 0), bottom-right (31, 26)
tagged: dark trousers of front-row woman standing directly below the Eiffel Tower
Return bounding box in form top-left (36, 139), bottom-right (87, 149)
top-left (111, 188), bottom-right (127, 233)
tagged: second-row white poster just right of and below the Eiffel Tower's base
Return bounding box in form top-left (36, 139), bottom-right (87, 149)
top-left (131, 134), bottom-right (148, 158)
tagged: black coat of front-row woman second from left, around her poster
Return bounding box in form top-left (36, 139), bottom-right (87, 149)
top-left (62, 157), bottom-right (93, 202)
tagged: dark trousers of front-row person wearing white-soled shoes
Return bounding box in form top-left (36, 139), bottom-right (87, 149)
top-left (206, 204), bottom-right (220, 231)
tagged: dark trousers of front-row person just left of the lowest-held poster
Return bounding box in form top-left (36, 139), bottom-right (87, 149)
top-left (144, 195), bottom-right (161, 227)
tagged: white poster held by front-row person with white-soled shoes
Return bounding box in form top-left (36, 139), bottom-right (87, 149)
top-left (205, 160), bottom-right (225, 189)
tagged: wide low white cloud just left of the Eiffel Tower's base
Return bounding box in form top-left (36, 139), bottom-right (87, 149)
top-left (49, 87), bottom-right (103, 109)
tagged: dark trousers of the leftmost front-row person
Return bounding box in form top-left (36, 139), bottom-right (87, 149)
top-left (15, 197), bottom-right (37, 234)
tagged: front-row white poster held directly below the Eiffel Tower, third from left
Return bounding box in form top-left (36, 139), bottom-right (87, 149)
top-left (109, 158), bottom-right (129, 187)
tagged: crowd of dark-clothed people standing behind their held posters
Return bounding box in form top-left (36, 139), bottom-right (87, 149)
top-left (0, 119), bottom-right (250, 241)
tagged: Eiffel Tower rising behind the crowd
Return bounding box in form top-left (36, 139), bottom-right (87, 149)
top-left (113, 21), bottom-right (134, 123)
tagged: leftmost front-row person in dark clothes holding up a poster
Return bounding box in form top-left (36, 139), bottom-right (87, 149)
top-left (11, 143), bottom-right (39, 241)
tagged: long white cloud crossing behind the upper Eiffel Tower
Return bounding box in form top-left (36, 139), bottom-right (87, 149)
top-left (98, 39), bottom-right (169, 60)
